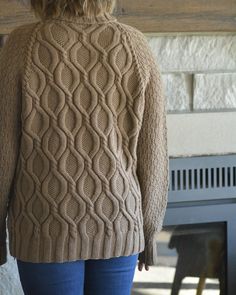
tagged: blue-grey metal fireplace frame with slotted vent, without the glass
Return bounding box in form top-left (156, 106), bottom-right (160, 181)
top-left (163, 154), bottom-right (236, 295)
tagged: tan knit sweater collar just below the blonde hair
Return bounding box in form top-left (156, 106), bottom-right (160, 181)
top-left (47, 12), bottom-right (117, 24)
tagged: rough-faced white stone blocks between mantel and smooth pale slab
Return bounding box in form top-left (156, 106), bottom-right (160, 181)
top-left (147, 34), bottom-right (236, 112)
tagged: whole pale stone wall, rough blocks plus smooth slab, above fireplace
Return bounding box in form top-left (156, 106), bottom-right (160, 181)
top-left (147, 33), bottom-right (236, 157)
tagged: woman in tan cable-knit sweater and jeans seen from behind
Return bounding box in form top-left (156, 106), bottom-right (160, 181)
top-left (0, 0), bottom-right (169, 295)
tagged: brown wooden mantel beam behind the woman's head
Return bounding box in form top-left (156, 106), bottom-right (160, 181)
top-left (0, 0), bottom-right (236, 34)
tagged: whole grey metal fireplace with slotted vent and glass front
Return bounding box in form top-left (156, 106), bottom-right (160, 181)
top-left (133, 155), bottom-right (236, 295)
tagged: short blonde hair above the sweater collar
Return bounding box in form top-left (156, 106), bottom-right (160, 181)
top-left (30, 0), bottom-right (116, 19)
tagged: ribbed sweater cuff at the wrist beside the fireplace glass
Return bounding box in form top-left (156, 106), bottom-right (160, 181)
top-left (138, 231), bottom-right (159, 266)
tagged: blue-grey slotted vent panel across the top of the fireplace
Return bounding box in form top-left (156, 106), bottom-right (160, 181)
top-left (169, 155), bottom-right (236, 204)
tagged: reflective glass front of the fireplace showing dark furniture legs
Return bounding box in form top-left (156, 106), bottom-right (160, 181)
top-left (132, 222), bottom-right (227, 295)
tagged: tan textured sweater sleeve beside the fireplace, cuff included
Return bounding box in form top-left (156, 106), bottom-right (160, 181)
top-left (131, 30), bottom-right (169, 265)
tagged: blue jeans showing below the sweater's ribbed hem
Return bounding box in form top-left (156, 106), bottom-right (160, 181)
top-left (16, 254), bottom-right (138, 295)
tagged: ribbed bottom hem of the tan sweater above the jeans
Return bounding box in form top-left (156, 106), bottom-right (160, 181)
top-left (8, 220), bottom-right (145, 263)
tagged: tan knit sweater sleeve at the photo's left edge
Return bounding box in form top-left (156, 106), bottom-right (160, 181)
top-left (0, 30), bottom-right (22, 265)
